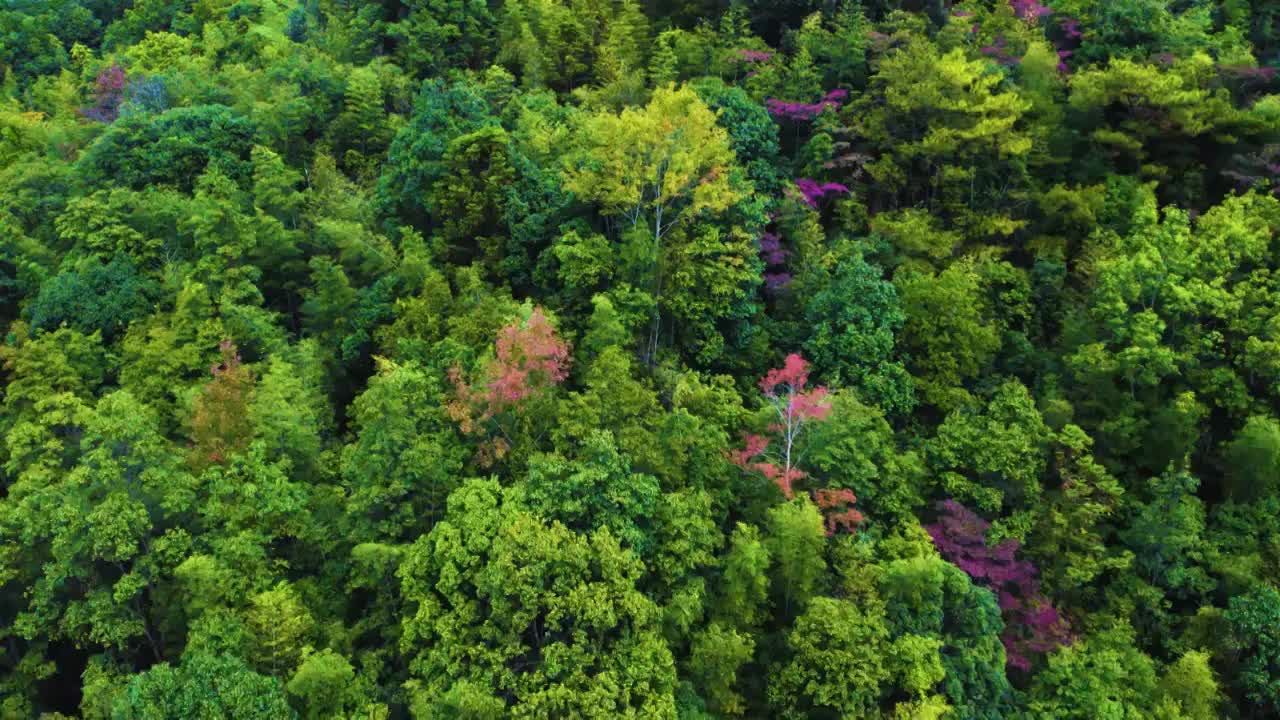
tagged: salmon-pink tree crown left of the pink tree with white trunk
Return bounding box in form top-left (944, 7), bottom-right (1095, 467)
top-left (448, 307), bottom-right (572, 460)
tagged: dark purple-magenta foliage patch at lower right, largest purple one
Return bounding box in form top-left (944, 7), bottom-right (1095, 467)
top-left (925, 500), bottom-right (1071, 671)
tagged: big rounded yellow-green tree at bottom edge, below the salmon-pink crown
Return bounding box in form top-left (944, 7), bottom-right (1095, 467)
top-left (399, 480), bottom-right (676, 719)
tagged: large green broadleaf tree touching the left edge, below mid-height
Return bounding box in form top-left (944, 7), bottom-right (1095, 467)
top-left (0, 391), bottom-right (195, 661)
